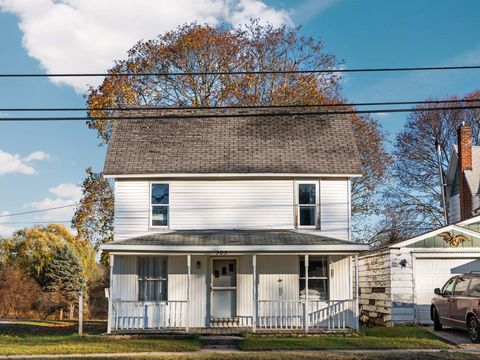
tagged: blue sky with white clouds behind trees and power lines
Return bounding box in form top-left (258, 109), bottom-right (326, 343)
top-left (0, 0), bottom-right (480, 235)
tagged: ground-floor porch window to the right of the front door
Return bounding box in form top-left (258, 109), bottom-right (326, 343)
top-left (299, 256), bottom-right (328, 300)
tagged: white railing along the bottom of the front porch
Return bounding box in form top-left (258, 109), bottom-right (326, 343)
top-left (110, 300), bottom-right (358, 334)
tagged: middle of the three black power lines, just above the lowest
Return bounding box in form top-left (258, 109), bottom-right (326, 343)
top-left (0, 99), bottom-right (480, 112)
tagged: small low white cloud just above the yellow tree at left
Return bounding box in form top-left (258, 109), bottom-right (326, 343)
top-left (23, 183), bottom-right (82, 222)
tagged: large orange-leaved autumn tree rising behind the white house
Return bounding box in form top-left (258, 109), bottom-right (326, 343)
top-left (82, 20), bottom-right (389, 242)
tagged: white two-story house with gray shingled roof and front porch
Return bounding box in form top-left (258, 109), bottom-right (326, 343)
top-left (102, 108), bottom-right (366, 332)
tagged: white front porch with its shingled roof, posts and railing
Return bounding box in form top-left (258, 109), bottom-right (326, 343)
top-left (103, 230), bottom-right (365, 332)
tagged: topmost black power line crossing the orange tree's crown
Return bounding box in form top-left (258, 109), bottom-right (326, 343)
top-left (0, 65), bottom-right (480, 78)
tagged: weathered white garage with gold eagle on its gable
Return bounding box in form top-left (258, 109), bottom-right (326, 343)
top-left (359, 216), bottom-right (480, 326)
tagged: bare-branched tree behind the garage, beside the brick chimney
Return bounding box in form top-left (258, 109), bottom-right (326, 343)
top-left (372, 91), bottom-right (480, 242)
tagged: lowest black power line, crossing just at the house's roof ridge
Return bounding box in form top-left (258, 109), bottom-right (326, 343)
top-left (0, 106), bottom-right (480, 122)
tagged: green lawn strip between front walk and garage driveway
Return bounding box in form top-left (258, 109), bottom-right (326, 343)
top-left (240, 326), bottom-right (450, 351)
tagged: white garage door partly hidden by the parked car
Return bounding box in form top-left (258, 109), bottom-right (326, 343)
top-left (414, 254), bottom-right (480, 324)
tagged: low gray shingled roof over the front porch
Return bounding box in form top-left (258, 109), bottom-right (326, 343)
top-left (107, 230), bottom-right (357, 246)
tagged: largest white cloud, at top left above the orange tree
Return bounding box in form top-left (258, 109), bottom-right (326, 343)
top-left (0, 0), bottom-right (292, 93)
